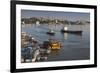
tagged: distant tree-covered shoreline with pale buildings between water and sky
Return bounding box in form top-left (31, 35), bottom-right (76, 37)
top-left (21, 17), bottom-right (90, 25)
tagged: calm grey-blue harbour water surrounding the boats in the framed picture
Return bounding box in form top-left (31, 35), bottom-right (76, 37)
top-left (22, 24), bottom-right (90, 61)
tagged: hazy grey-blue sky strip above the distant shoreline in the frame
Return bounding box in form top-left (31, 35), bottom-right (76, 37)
top-left (21, 10), bottom-right (90, 21)
